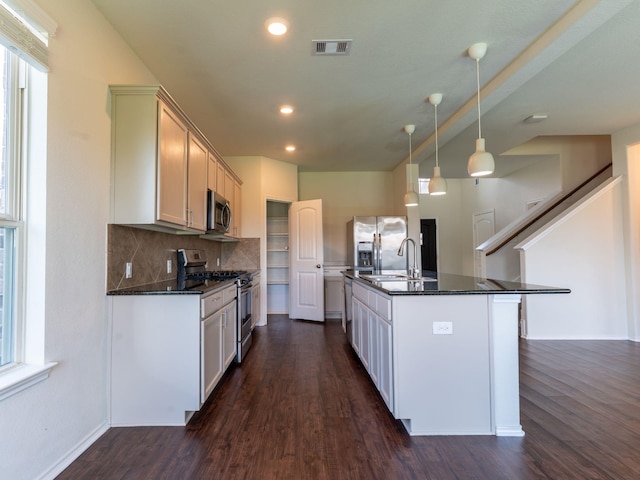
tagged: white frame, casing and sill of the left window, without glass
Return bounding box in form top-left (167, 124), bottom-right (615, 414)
top-left (0, 0), bottom-right (57, 401)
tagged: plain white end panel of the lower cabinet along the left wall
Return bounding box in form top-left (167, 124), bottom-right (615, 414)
top-left (107, 295), bottom-right (201, 427)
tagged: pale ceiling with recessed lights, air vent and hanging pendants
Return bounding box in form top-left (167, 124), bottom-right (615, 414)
top-left (91, 0), bottom-right (640, 178)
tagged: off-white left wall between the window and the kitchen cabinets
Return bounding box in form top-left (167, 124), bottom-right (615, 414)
top-left (0, 0), bottom-right (157, 480)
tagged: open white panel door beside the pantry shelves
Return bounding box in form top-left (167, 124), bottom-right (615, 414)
top-left (289, 200), bottom-right (324, 322)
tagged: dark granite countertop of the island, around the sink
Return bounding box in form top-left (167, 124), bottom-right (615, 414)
top-left (343, 270), bottom-right (571, 295)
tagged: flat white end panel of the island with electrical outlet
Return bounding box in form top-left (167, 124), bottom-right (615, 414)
top-left (393, 295), bottom-right (495, 435)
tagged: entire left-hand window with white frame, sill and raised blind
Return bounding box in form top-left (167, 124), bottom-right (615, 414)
top-left (0, 0), bottom-right (57, 401)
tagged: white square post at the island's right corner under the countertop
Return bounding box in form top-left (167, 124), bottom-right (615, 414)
top-left (489, 294), bottom-right (524, 437)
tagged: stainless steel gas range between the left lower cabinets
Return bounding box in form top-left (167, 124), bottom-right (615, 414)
top-left (178, 249), bottom-right (253, 363)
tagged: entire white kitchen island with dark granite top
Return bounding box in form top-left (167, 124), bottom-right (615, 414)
top-left (343, 271), bottom-right (570, 436)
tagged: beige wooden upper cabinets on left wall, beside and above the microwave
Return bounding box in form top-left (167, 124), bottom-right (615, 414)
top-left (110, 85), bottom-right (241, 234)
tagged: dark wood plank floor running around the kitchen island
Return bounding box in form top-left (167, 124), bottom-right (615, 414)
top-left (58, 316), bottom-right (640, 480)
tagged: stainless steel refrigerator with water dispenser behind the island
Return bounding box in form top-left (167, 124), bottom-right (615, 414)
top-left (347, 216), bottom-right (408, 272)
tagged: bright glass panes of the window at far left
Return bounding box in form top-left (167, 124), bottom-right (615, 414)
top-left (0, 46), bottom-right (23, 368)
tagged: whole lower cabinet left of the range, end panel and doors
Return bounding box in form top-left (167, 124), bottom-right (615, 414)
top-left (107, 285), bottom-right (237, 427)
